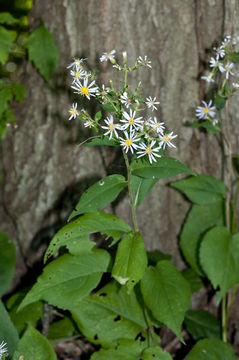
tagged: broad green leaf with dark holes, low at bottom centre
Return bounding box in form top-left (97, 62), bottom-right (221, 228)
top-left (71, 282), bottom-right (147, 347)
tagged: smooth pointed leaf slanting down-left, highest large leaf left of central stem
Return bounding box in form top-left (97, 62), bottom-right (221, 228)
top-left (68, 175), bottom-right (127, 220)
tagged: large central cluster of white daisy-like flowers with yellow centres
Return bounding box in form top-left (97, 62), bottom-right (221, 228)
top-left (68, 50), bottom-right (177, 163)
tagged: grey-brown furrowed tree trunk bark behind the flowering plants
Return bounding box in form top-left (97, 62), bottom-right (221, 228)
top-left (0, 0), bottom-right (239, 276)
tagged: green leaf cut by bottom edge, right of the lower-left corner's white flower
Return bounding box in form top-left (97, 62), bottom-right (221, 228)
top-left (17, 326), bottom-right (57, 360)
